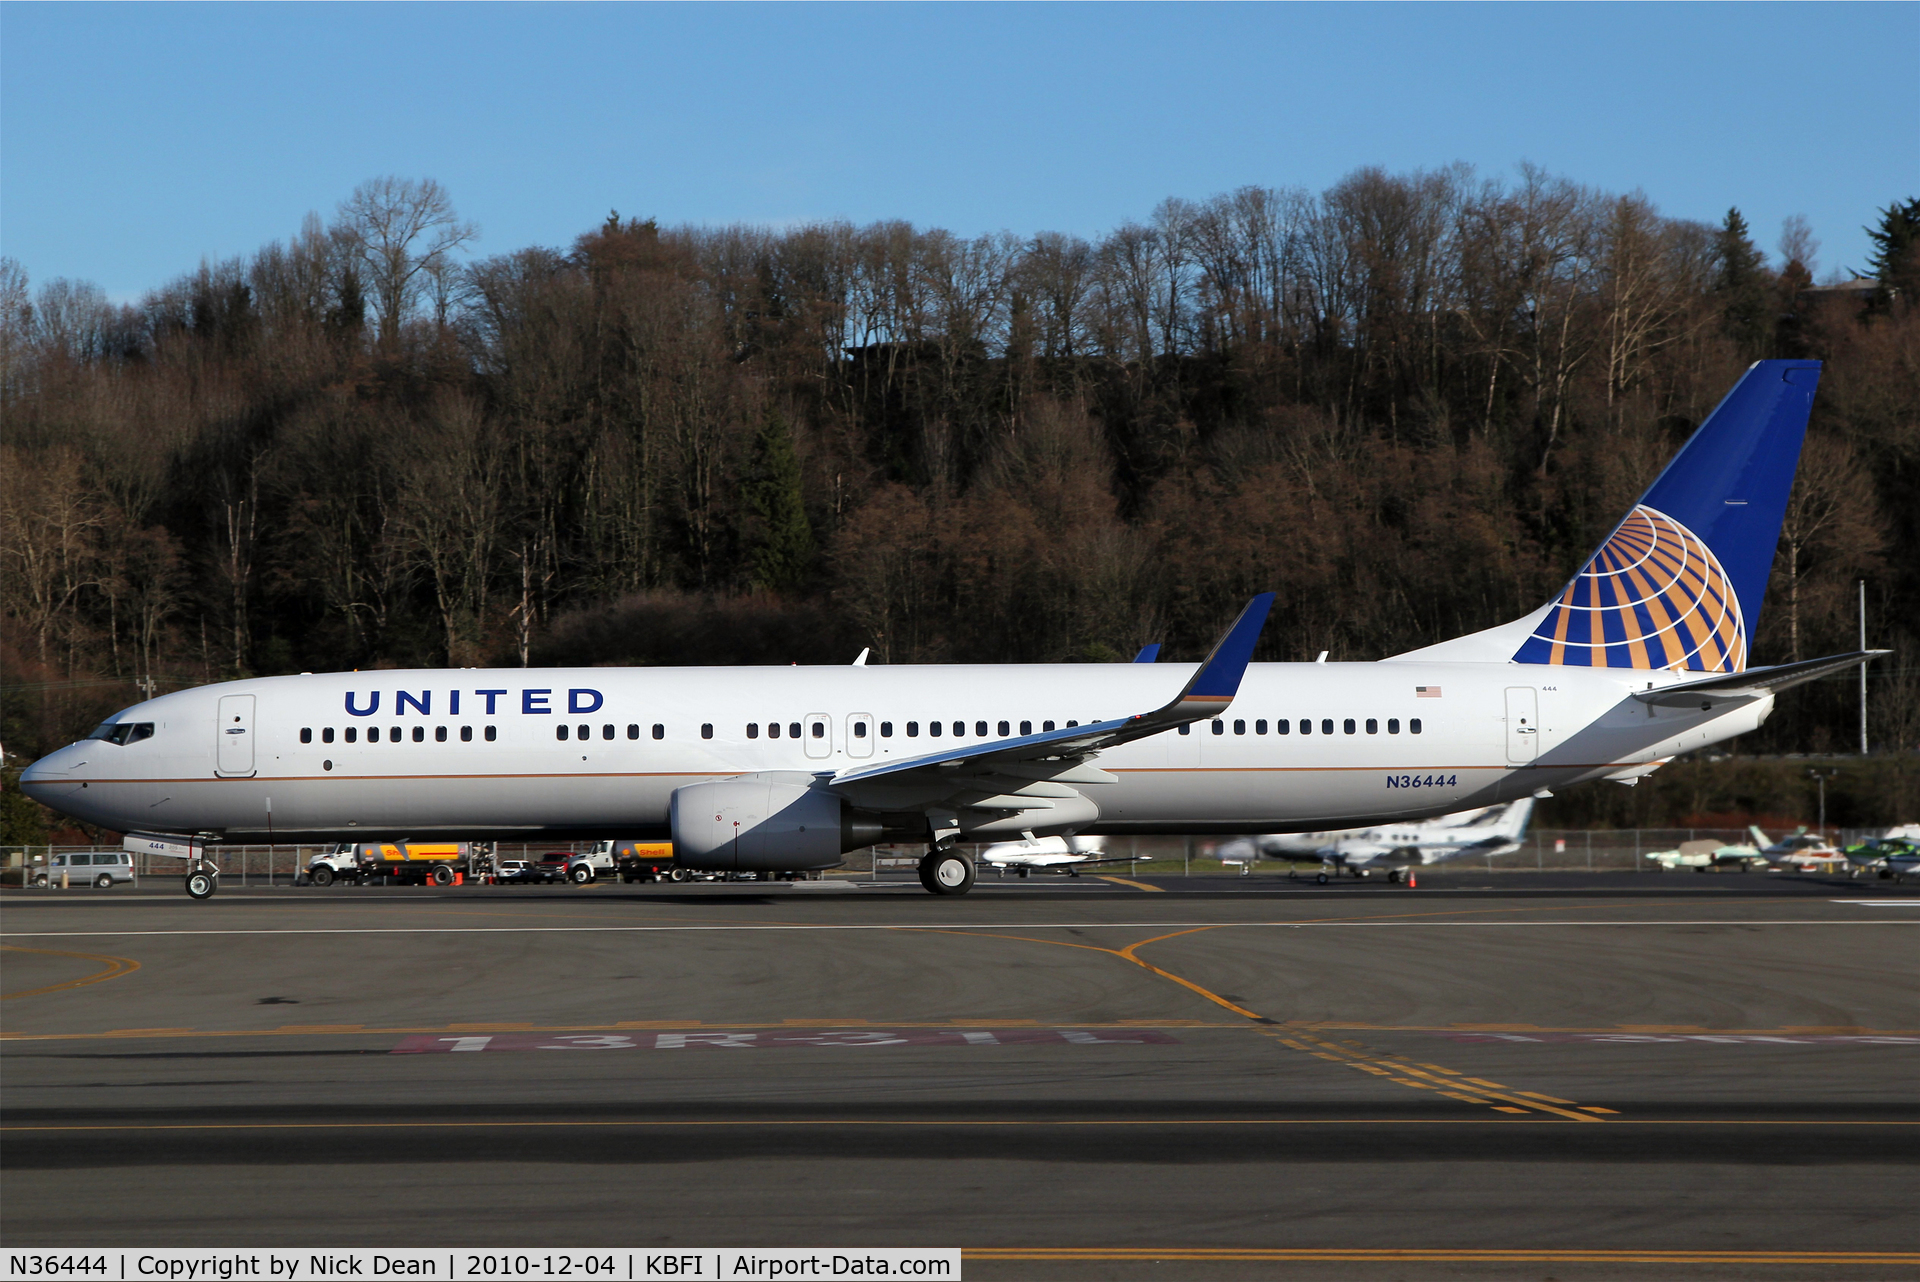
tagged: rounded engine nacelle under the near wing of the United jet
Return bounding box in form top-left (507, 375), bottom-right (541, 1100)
top-left (670, 775), bottom-right (881, 873)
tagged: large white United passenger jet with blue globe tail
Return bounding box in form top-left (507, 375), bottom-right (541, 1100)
top-left (21, 361), bottom-right (1880, 898)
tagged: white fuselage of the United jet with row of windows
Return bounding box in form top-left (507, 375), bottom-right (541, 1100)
top-left (23, 660), bottom-right (1772, 841)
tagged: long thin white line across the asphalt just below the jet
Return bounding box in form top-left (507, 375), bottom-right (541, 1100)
top-left (0, 917), bottom-right (1920, 938)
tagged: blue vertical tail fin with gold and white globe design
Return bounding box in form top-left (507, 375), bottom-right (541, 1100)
top-left (1513, 361), bottom-right (1820, 672)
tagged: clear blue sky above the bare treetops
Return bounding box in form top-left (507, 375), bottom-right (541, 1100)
top-left (0, 2), bottom-right (1920, 299)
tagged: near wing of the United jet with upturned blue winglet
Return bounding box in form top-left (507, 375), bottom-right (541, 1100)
top-left (828, 593), bottom-right (1273, 810)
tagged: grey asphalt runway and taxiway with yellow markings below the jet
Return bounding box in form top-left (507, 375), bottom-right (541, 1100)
top-left (0, 873), bottom-right (1920, 1280)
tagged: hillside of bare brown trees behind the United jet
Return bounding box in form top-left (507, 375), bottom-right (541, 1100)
top-left (0, 169), bottom-right (1920, 771)
